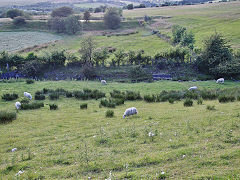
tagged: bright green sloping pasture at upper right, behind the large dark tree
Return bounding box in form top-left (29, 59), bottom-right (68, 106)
top-left (123, 1), bottom-right (240, 48)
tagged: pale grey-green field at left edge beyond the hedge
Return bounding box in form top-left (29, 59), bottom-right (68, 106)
top-left (0, 32), bottom-right (62, 52)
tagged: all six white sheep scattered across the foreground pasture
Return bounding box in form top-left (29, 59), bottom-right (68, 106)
top-left (15, 78), bottom-right (224, 119)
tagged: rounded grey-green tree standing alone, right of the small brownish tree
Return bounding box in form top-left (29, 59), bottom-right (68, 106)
top-left (104, 7), bottom-right (121, 29)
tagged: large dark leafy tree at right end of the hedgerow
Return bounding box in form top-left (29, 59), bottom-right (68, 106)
top-left (196, 33), bottom-right (233, 74)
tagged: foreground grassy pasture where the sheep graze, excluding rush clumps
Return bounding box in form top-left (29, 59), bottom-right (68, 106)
top-left (0, 81), bottom-right (240, 179)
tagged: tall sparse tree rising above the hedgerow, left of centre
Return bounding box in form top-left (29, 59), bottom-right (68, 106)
top-left (79, 36), bottom-right (96, 64)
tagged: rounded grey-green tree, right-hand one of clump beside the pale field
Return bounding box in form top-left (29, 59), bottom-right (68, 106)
top-left (64, 16), bottom-right (81, 34)
